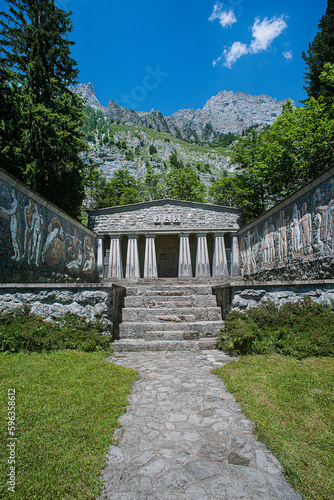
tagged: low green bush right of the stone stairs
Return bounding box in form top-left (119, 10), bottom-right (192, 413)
top-left (218, 297), bottom-right (334, 359)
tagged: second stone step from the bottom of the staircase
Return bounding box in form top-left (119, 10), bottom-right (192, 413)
top-left (119, 320), bottom-right (223, 339)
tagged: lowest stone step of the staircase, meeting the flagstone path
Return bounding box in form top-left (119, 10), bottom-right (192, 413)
top-left (111, 338), bottom-right (217, 352)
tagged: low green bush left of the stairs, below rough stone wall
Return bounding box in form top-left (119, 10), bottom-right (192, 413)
top-left (0, 313), bottom-right (111, 352)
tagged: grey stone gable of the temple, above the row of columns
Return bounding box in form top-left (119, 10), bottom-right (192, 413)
top-left (88, 200), bottom-right (242, 234)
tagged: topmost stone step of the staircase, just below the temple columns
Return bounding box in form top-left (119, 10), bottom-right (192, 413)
top-left (126, 285), bottom-right (212, 297)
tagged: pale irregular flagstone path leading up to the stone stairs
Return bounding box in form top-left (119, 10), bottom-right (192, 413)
top-left (97, 351), bottom-right (300, 500)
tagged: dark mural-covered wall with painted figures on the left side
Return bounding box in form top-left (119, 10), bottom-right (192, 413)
top-left (0, 169), bottom-right (96, 283)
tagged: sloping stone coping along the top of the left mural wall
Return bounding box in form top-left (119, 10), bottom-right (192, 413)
top-left (0, 168), bottom-right (96, 237)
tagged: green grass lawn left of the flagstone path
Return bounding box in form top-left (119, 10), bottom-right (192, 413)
top-left (0, 351), bottom-right (136, 500)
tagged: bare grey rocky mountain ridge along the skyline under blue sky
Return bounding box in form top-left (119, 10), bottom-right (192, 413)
top-left (72, 83), bottom-right (294, 142)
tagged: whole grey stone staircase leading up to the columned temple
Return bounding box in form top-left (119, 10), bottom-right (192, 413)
top-left (112, 280), bottom-right (222, 352)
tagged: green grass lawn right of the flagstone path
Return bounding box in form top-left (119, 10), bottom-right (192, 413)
top-left (215, 355), bottom-right (334, 500)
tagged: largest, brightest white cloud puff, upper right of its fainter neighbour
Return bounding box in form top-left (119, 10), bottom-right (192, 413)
top-left (249, 15), bottom-right (287, 54)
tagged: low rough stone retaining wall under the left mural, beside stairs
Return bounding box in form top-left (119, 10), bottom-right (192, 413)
top-left (0, 283), bottom-right (125, 338)
